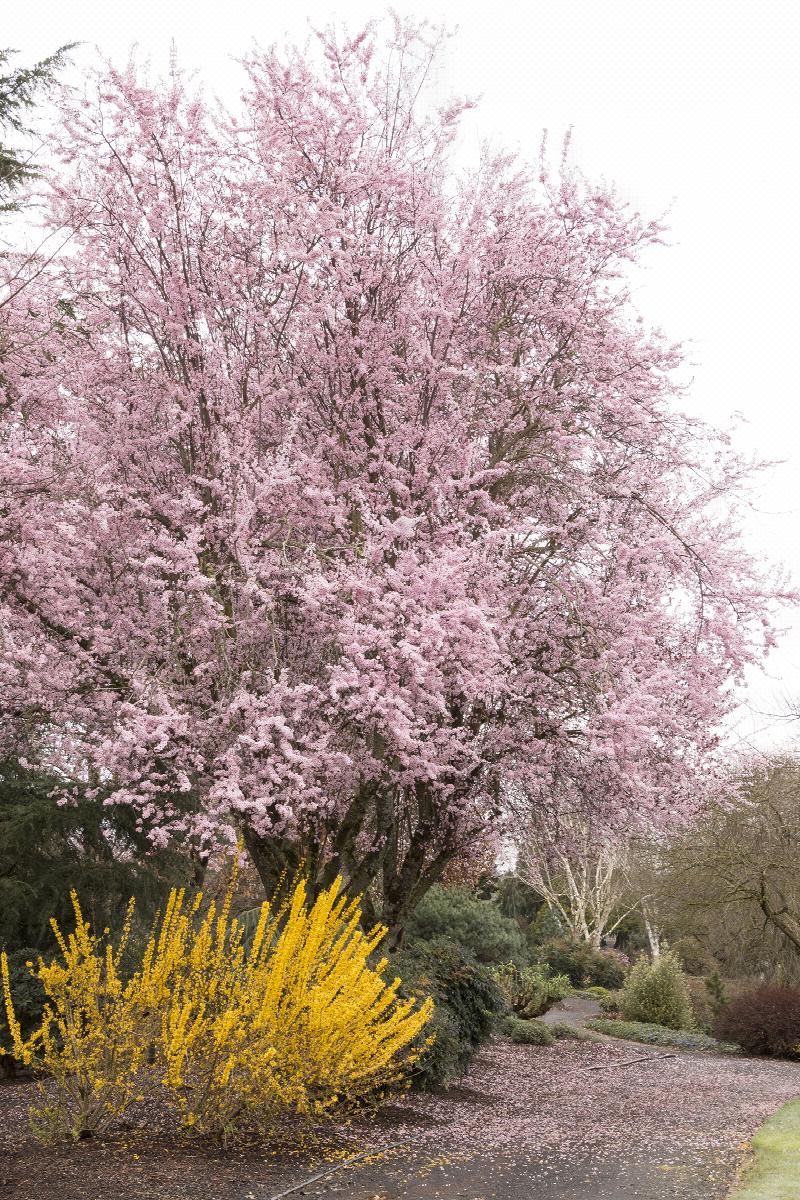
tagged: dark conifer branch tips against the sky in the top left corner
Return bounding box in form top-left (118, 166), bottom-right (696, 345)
top-left (0, 46), bottom-right (73, 204)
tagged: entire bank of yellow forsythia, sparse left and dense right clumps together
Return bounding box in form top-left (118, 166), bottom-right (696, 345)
top-left (4, 872), bottom-right (433, 1136)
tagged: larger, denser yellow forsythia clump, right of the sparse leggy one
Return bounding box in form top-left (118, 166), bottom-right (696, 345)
top-left (155, 882), bottom-right (433, 1134)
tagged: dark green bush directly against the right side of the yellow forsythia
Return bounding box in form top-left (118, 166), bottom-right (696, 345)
top-left (389, 941), bottom-right (505, 1090)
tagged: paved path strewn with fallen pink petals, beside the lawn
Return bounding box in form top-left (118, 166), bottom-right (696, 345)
top-left (284, 1036), bottom-right (800, 1200)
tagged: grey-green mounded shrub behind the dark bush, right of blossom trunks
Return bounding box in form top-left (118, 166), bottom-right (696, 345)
top-left (405, 883), bottom-right (528, 964)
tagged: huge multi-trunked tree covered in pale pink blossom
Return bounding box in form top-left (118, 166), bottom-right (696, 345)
top-left (0, 25), bottom-right (786, 925)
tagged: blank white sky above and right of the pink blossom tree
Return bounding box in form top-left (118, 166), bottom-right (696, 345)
top-left (6, 0), bottom-right (800, 746)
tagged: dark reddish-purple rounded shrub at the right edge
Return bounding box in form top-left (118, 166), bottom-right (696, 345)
top-left (715, 984), bottom-right (800, 1058)
